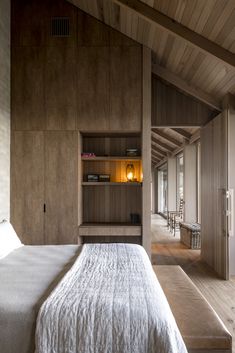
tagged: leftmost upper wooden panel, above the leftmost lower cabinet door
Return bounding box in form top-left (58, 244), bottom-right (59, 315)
top-left (11, 47), bottom-right (45, 130)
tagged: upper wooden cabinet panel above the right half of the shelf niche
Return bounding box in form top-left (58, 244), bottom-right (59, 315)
top-left (110, 46), bottom-right (142, 132)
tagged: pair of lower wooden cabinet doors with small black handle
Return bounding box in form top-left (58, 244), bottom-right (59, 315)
top-left (11, 131), bottom-right (78, 245)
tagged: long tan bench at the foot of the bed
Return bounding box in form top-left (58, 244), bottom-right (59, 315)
top-left (153, 266), bottom-right (232, 353)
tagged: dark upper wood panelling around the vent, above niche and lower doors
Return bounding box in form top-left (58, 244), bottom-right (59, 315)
top-left (12, 0), bottom-right (142, 132)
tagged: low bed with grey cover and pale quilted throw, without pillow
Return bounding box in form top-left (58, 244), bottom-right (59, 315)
top-left (0, 220), bottom-right (187, 353)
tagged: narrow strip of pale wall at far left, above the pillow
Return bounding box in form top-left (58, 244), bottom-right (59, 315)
top-left (0, 0), bottom-right (10, 221)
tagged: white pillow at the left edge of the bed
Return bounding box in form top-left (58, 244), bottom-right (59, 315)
top-left (0, 220), bottom-right (23, 259)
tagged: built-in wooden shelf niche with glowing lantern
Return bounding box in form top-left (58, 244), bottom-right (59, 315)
top-left (79, 134), bottom-right (142, 234)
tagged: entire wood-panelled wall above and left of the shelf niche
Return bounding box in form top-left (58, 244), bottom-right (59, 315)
top-left (11, 0), bottom-right (142, 244)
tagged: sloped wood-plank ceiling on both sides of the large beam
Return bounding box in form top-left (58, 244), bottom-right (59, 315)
top-left (66, 0), bottom-right (235, 106)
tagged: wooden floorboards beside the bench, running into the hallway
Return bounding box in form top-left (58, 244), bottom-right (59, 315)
top-left (152, 216), bottom-right (235, 353)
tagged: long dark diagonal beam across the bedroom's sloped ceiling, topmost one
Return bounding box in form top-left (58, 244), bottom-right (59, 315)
top-left (113, 0), bottom-right (235, 68)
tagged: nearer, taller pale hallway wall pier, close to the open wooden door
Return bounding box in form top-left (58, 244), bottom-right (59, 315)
top-left (184, 144), bottom-right (197, 222)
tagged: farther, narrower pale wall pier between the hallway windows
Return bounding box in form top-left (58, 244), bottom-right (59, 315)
top-left (167, 157), bottom-right (178, 211)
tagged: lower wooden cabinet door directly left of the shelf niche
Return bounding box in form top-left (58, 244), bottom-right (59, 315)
top-left (45, 131), bottom-right (78, 244)
